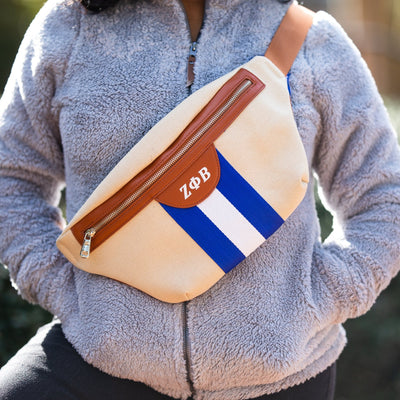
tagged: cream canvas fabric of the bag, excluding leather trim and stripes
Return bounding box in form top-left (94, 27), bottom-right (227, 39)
top-left (57, 56), bottom-right (308, 303)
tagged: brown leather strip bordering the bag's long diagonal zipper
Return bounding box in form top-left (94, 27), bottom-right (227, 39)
top-left (71, 68), bottom-right (265, 252)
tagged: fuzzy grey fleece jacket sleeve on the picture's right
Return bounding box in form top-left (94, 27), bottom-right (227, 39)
top-left (306, 13), bottom-right (400, 322)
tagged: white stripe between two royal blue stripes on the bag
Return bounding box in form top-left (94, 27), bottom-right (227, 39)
top-left (197, 189), bottom-right (265, 257)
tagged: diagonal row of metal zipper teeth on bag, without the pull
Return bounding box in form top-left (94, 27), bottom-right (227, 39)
top-left (90, 79), bottom-right (252, 236)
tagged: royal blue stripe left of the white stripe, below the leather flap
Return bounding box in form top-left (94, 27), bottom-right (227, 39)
top-left (161, 204), bottom-right (245, 272)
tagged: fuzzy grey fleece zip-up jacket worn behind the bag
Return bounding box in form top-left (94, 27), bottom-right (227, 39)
top-left (0, 0), bottom-right (400, 400)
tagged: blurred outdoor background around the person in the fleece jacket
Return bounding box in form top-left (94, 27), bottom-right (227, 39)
top-left (0, 0), bottom-right (400, 400)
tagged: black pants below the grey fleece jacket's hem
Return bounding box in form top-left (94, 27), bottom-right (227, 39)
top-left (0, 324), bottom-right (336, 400)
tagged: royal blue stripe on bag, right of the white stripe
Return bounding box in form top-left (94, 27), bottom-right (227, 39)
top-left (217, 152), bottom-right (284, 239)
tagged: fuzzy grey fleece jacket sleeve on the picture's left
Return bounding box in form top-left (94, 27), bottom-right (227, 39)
top-left (0, 0), bottom-right (78, 314)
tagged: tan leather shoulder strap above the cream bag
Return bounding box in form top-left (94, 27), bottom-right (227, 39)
top-left (265, 2), bottom-right (314, 75)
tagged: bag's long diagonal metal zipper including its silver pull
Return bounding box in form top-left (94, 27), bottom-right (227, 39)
top-left (80, 78), bottom-right (253, 258)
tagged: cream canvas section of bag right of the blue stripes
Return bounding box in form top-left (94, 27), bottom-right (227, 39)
top-left (215, 57), bottom-right (309, 219)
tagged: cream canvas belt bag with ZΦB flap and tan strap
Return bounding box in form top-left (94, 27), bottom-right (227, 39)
top-left (57, 4), bottom-right (312, 303)
